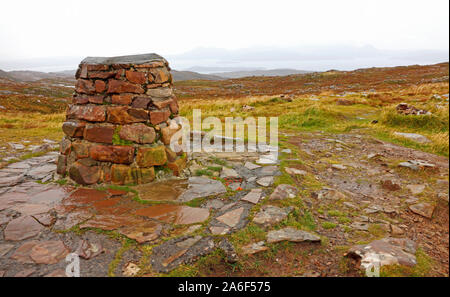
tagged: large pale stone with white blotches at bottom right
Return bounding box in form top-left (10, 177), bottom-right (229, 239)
top-left (346, 237), bottom-right (417, 269)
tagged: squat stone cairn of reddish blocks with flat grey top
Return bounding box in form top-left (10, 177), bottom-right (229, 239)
top-left (57, 54), bottom-right (186, 185)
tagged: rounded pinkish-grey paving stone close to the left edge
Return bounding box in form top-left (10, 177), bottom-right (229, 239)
top-left (4, 216), bottom-right (44, 241)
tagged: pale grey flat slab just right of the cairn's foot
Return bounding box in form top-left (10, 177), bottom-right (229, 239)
top-left (178, 177), bottom-right (227, 202)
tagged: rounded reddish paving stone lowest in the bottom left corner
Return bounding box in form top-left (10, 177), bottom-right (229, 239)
top-left (30, 240), bottom-right (69, 264)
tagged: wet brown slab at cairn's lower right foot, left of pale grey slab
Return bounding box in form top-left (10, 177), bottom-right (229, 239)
top-left (134, 179), bottom-right (188, 201)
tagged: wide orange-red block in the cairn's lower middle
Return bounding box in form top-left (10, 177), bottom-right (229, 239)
top-left (89, 145), bottom-right (134, 164)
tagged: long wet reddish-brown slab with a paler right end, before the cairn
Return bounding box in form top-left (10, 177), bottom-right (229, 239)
top-left (135, 204), bottom-right (209, 225)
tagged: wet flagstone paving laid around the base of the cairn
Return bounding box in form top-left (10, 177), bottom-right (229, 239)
top-left (0, 142), bottom-right (320, 277)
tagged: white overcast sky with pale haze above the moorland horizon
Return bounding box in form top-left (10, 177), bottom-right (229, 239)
top-left (0, 0), bottom-right (449, 70)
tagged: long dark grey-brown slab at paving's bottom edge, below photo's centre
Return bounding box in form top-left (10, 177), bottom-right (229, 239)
top-left (150, 236), bottom-right (216, 273)
